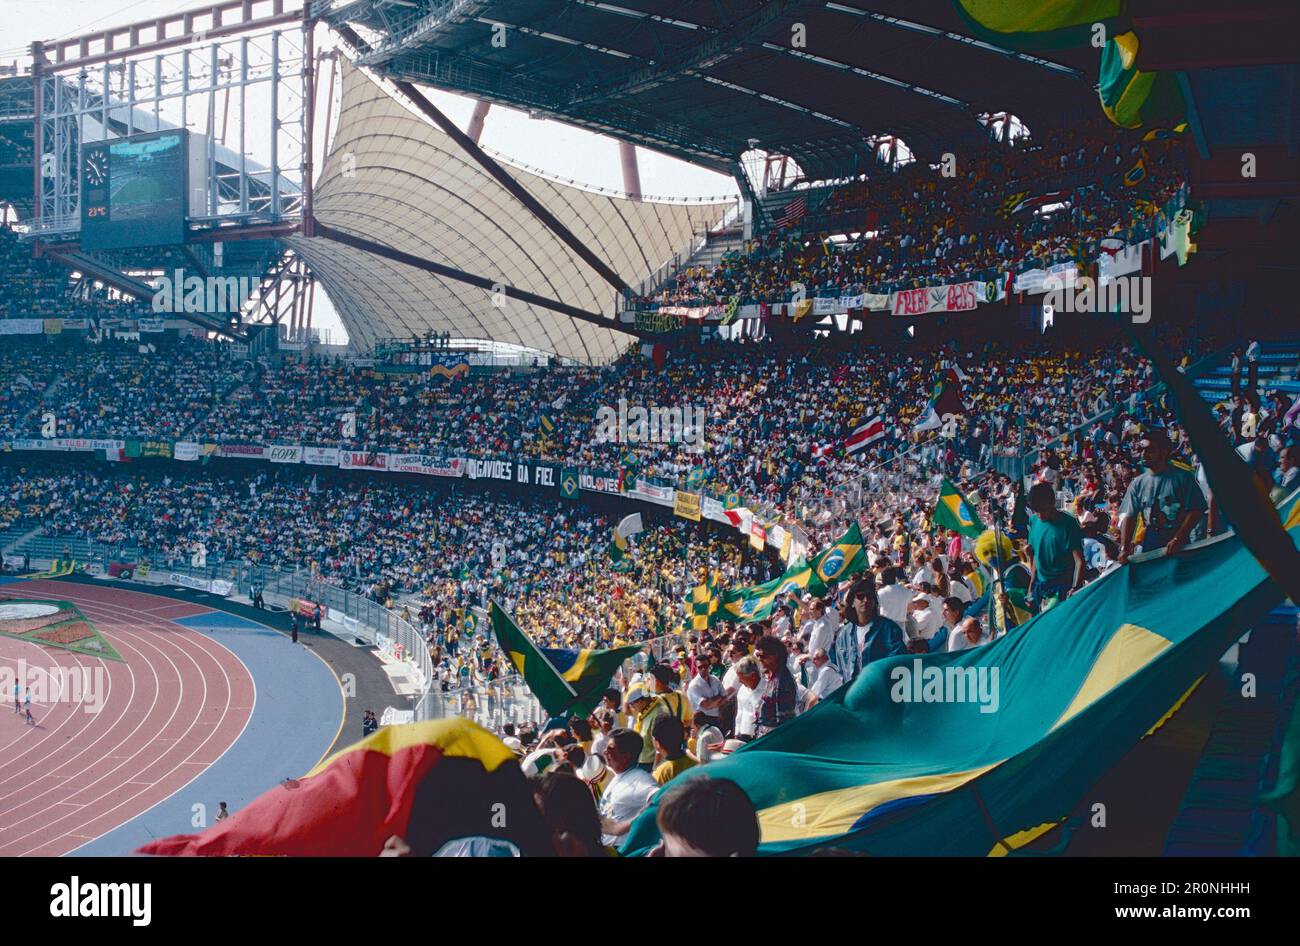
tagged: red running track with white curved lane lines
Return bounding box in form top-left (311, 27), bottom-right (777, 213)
top-left (0, 581), bottom-right (256, 858)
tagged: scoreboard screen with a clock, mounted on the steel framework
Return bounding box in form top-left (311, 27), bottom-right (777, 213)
top-left (81, 129), bottom-right (189, 249)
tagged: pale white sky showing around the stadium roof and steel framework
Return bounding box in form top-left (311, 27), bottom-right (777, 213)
top-left (0, 0), bottom-right (736, 342)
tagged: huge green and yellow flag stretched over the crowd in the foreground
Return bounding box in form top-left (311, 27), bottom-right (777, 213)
top-left (623, 500), bottom-right (1300, 855)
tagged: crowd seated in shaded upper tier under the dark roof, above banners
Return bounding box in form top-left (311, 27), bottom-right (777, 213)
top-left (650, 120), bottom-right (1187, 305)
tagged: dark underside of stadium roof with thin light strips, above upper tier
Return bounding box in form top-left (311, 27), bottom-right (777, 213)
top-left (312, 0), bottom-right (1099, 179)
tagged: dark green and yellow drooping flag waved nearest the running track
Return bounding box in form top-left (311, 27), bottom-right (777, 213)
top-left (490, 602), bottom-right (641, 716)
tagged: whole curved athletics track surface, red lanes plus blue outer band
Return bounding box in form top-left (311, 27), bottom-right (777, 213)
top-left (0, 581), bottom-right (343, 856)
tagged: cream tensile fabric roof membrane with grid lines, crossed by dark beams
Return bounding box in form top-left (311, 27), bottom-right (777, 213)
top-left (286, 62), bottom-right (735, 364)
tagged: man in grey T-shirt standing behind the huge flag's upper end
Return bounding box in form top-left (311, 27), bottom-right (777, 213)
top-left (1119, 428), bottom-right (1206, 565)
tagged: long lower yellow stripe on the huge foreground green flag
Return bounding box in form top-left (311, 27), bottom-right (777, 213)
top-left (758, 761), bottom-right (1001, 845)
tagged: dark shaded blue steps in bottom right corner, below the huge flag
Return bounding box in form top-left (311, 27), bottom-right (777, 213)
top-left (1164, 607), bottom-right (1300, 856)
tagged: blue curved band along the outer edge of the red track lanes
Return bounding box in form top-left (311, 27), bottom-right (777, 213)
top-left (69, 611), bottom-right (343, 856)
